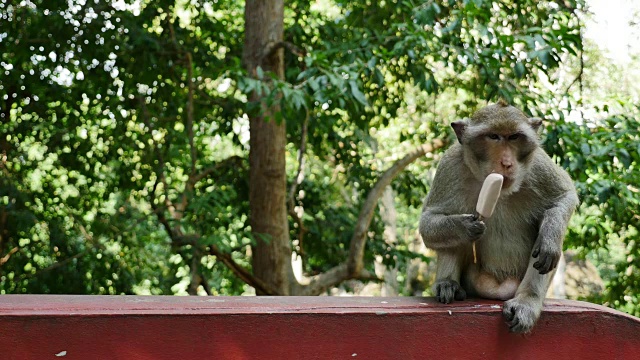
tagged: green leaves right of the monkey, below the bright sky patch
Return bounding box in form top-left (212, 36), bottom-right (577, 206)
top-left (545, 112), bottom-right (640, 314)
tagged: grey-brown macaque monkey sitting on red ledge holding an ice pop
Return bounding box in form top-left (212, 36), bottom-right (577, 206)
top-left (420, 101), bottom-right (578, 333)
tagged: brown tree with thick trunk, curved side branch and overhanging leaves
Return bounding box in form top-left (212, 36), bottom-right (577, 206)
top-left (234, 2), bottom-right (579, 294)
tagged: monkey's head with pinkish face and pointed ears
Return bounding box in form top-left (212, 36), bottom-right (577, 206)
top-left (451, 101), bottom-right (542, 195)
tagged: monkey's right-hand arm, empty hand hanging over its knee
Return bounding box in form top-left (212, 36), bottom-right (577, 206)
top-left (531, 154), bottom-right (579, 274)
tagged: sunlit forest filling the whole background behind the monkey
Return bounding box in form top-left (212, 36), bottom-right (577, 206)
top-left (0, 0), bottom-right (640, 316)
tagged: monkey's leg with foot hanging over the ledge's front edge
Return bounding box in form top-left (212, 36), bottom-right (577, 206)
top-left (502, 250), bottom-right (555, 333)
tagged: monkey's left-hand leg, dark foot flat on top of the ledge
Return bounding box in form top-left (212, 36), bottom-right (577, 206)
top-left (433, 248), bottom-right (468, 304)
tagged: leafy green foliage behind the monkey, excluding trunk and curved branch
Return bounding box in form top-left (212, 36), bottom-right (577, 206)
top-left (0, 0), bottom-right (638, 318)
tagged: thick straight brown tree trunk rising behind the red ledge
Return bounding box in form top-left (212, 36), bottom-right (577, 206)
top-left (243, 0), bottom-right (293, 295)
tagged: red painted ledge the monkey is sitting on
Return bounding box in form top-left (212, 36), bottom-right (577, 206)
top-left (0, 295), bottom-right (640, 360)
